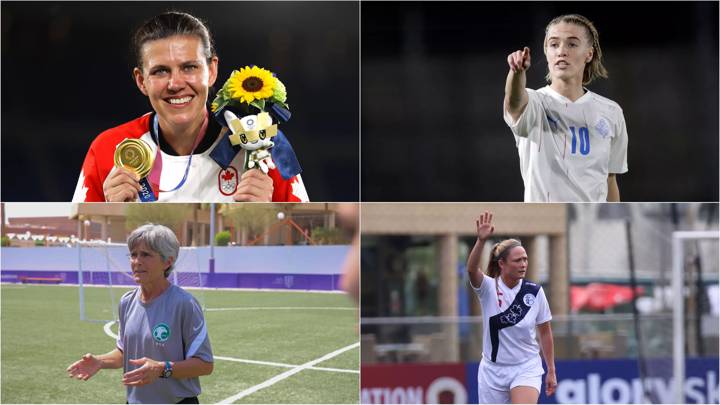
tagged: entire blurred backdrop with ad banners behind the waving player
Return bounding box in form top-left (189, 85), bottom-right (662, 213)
top-left (361, 203), bottom-right (720, 403)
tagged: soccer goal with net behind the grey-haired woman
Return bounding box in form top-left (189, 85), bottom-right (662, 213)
top-left (77, 242), bottom-right (208, 322)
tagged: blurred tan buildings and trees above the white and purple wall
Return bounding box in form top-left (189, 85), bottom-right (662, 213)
top-left (0, 203), bottom-right (352, 247)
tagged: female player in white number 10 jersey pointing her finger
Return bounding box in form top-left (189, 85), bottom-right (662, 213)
top-left (503, 14), bottom-right (628, 202)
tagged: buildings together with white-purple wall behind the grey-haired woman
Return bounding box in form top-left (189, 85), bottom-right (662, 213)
top-left (0, 203), bottom-right (357, 294)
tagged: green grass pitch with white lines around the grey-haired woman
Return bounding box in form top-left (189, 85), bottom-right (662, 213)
top-left (0, 284), bottom-right (360, 403)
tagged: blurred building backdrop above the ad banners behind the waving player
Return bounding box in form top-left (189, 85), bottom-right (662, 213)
top-left (361, 203), bottom-right (718, 363)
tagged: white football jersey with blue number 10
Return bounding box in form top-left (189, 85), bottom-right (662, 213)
top-left (503, 86), bottom-right (628, 202)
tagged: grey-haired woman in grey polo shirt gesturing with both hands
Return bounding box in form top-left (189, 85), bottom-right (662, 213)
top-left (67, 224), bottom-right (213, 403)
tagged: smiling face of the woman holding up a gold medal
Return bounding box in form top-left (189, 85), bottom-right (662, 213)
top-left (133, 35), bottom-right (218, 135)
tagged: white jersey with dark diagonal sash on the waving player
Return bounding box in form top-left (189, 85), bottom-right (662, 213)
top-left (472, 274), bottom-right (552, 365)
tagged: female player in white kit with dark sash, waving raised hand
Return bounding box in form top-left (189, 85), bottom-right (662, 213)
top-left (467, 212), bottom-right (557, 404)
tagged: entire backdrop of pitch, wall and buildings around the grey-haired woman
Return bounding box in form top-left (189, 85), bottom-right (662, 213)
top-left (0, 203), bottom-right (359, 403)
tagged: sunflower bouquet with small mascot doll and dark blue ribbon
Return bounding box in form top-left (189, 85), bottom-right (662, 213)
top-left (210, 66), bottom-right (300, 179)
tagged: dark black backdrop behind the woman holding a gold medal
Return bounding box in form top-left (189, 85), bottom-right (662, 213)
top-left (0, 1), bottom-right (360, 202)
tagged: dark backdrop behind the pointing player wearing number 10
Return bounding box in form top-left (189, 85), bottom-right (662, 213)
top-left (361, 1), bottom-right (719, 202)
